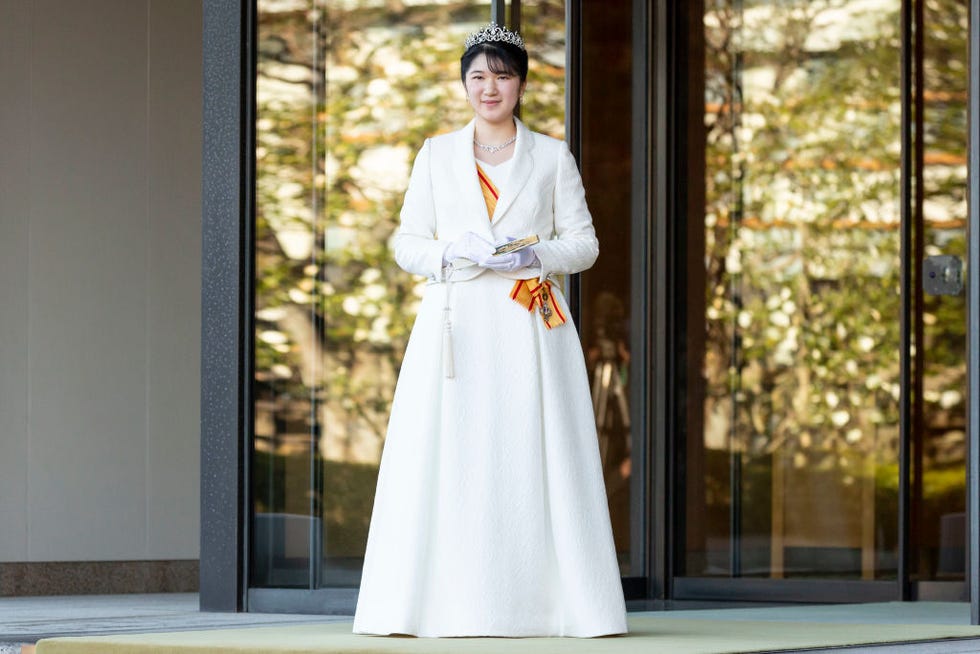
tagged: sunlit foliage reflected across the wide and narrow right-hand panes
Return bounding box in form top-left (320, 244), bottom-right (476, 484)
top-left (703, 0), bottom-right (967, 576)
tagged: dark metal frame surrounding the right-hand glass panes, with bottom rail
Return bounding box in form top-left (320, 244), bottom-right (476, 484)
top-left (648, 0), bottom-right (980, 608)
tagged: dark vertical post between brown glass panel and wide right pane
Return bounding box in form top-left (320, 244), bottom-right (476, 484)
top-left (644, 0), bottom-right (674, 599)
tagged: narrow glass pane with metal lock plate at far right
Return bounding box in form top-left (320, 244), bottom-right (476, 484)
top-left (910, 0), bottom-right (970, 588)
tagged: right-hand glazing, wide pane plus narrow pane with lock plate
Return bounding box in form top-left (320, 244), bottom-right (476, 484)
top-left (674, 0), bottom-right (968, 601)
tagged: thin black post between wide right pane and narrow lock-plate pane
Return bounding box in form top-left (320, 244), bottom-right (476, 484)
top-left (898, 0), bottom-right (916, 601)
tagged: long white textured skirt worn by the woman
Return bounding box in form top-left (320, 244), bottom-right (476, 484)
top-left (354, 272), bottom-right (627, 637)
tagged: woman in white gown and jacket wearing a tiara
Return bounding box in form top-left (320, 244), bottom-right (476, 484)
top-left (354, 23), bottom-right (627, 637)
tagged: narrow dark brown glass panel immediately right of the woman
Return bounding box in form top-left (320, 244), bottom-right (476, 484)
top-left (572, 2), bottom-right (644, 580)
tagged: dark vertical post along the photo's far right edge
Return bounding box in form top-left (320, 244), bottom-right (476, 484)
top-left (966, 0), bottom-right (980, 624)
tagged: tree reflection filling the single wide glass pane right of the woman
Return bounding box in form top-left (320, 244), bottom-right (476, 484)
top-left (687, 0), bottom-right (901, 578)
